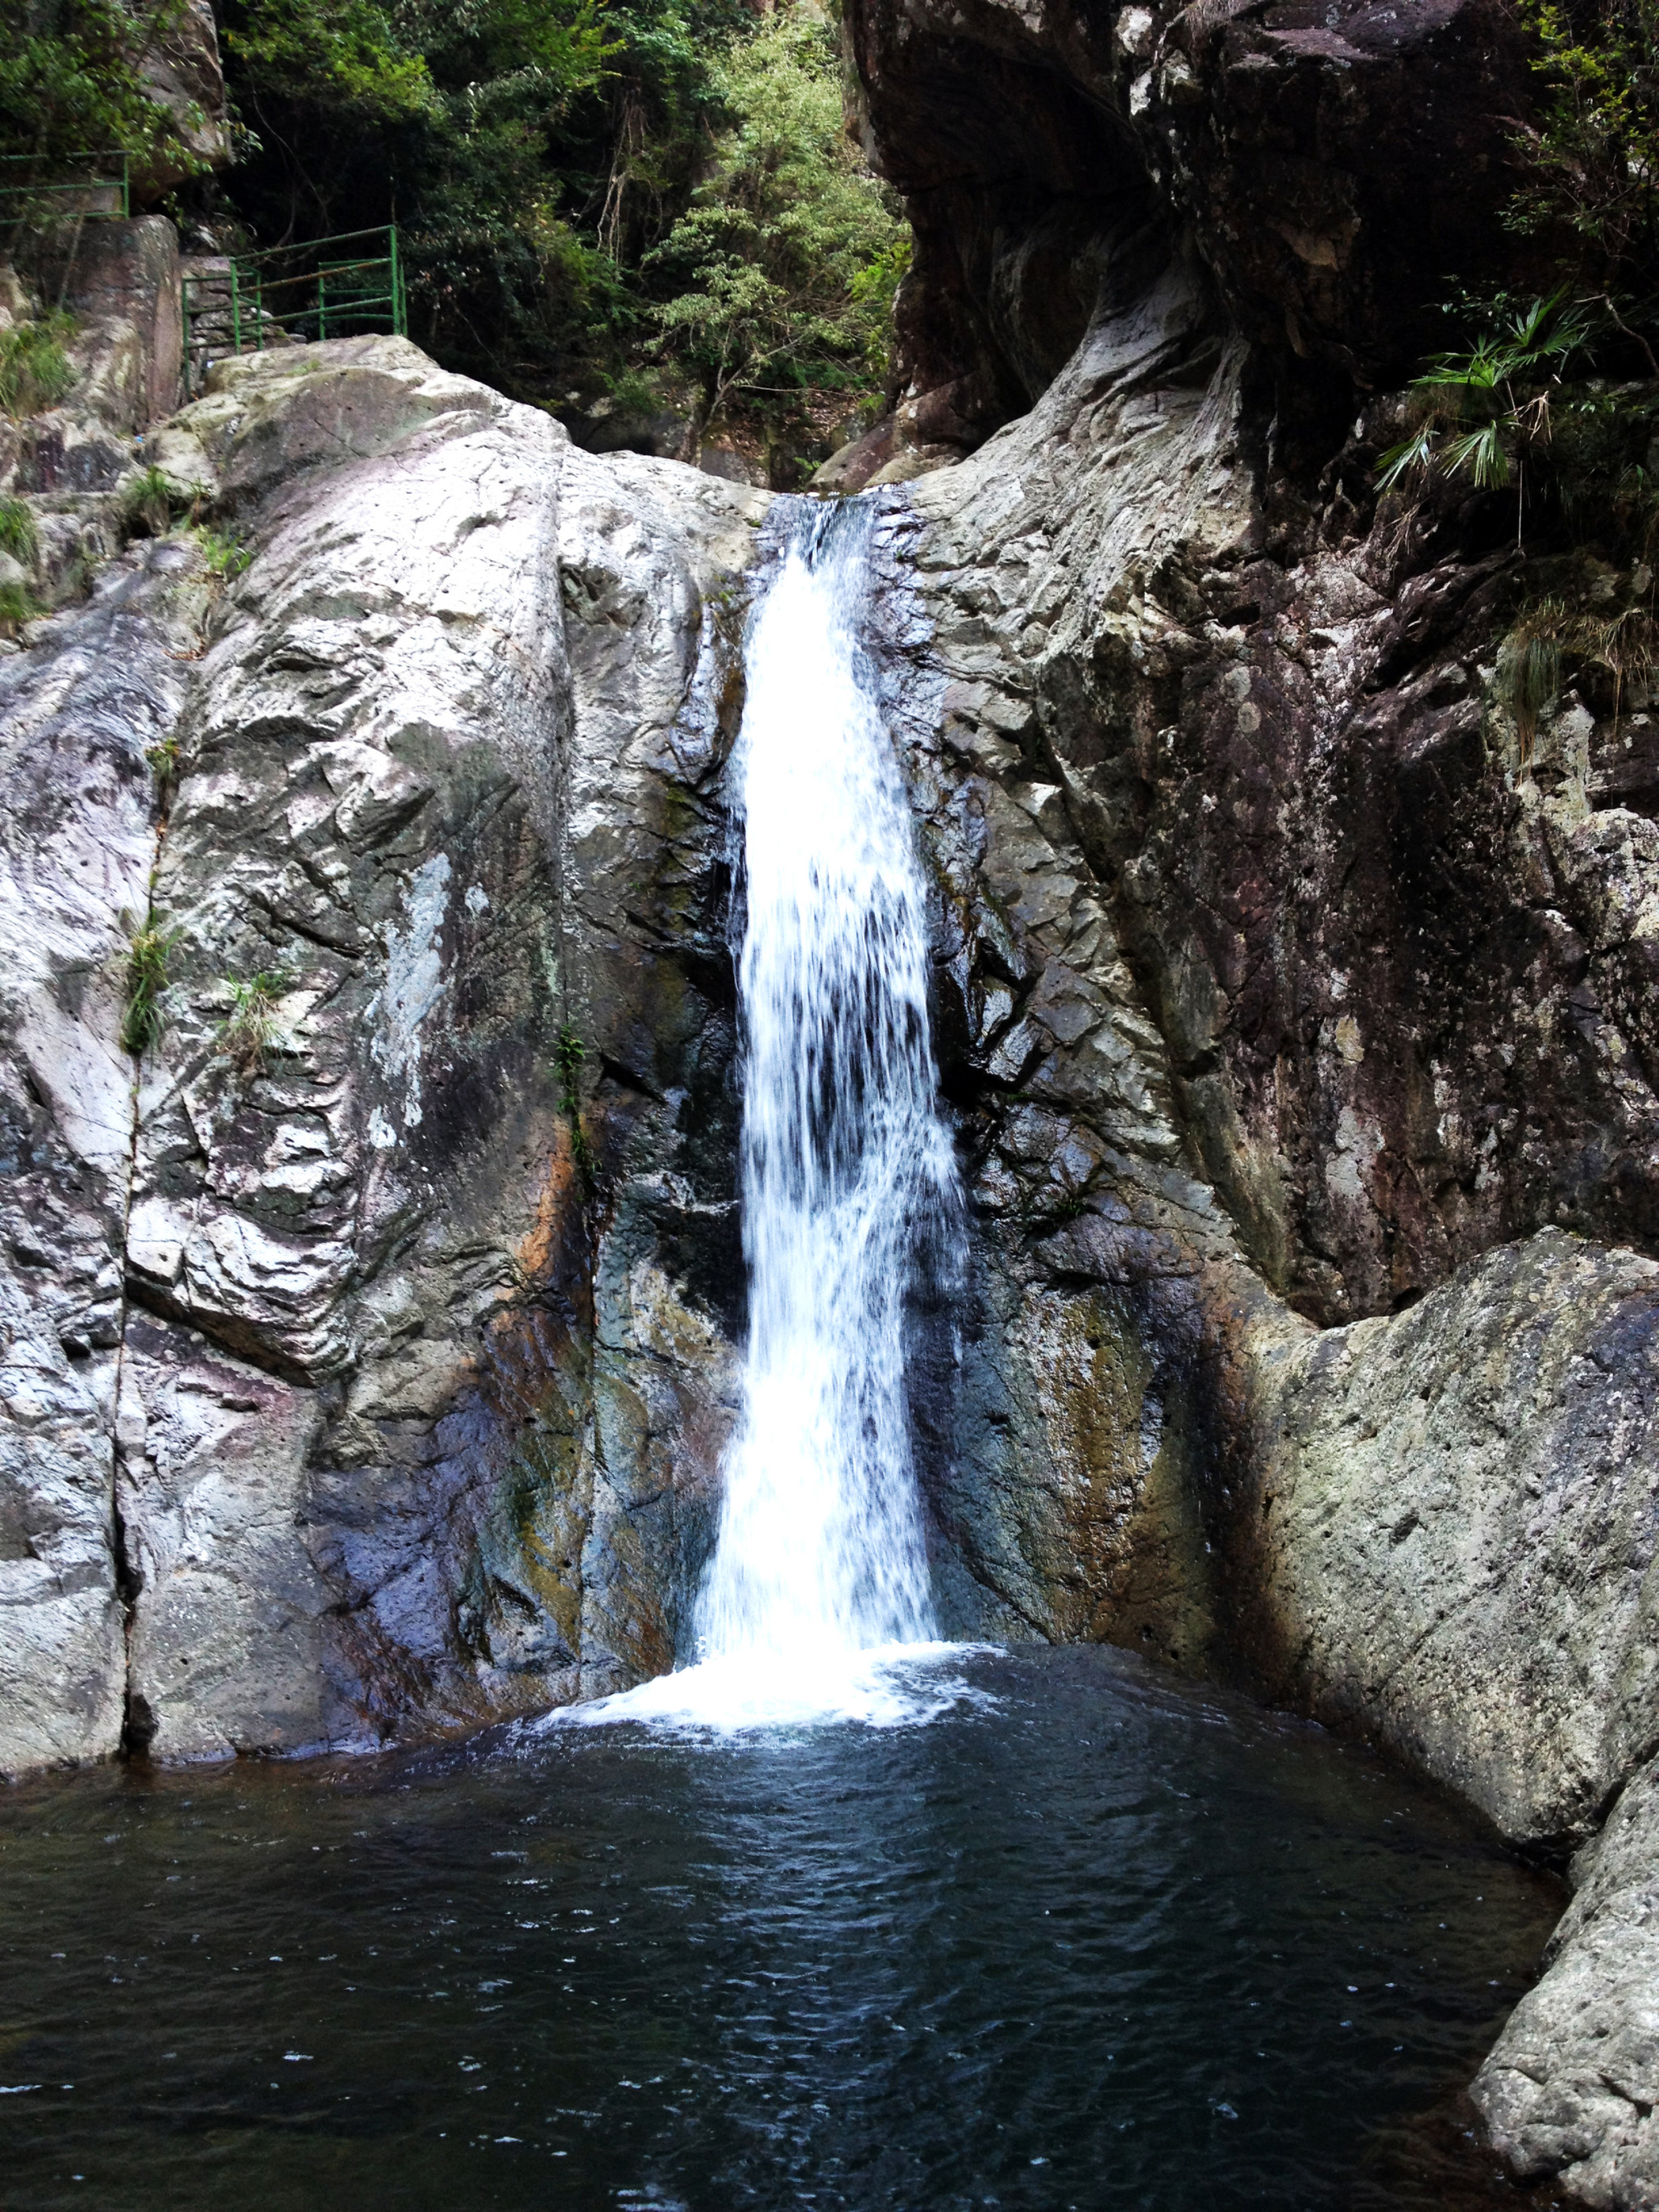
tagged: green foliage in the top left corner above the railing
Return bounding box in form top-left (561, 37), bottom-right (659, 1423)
top-left (0, 0), bottom-right (203, 194)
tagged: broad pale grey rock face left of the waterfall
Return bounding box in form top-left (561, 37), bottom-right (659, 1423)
top-left (0, 340), bottom-right (766, 1767)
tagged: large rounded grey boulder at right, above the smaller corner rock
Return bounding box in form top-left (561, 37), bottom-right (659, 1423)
top-left (1230, 1230), bottom-right (1659, 1847)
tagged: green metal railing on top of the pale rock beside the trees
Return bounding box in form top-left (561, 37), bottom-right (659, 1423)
top-left (184, 224), bottom-right (409, 396)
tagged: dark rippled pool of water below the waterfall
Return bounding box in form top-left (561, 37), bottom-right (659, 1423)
top-left (0, 1650), bottom-right (1559, 2212)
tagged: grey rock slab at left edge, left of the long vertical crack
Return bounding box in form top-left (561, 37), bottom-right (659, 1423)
top-left (0, 531), bottom-right (199, 1772)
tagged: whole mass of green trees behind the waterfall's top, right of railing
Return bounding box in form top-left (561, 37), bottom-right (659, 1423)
top-left (221, 0), bottom-right (907, 444)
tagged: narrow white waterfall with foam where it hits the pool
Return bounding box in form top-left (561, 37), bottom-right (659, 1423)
top-left (566, 509), bottom-right (971, 1727)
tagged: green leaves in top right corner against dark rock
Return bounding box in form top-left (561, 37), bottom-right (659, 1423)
top-left (1511, 0), bottom-right (1659, 307)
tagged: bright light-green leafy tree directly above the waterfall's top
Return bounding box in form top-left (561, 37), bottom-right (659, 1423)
top-left (646, 11), bottom-right (907, 435)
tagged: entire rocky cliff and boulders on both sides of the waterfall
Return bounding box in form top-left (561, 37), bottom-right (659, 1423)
top-left (0, 0), bottom-right (1659, 2208)
